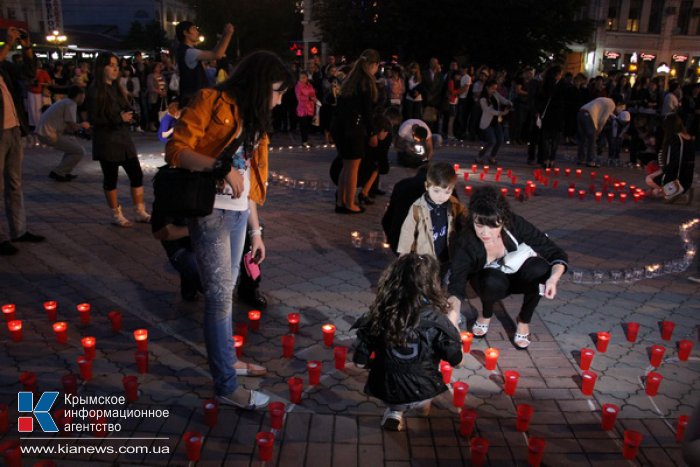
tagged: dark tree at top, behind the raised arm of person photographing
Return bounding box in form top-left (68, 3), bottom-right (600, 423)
top-left (193, 0), bottom-right (302, 59)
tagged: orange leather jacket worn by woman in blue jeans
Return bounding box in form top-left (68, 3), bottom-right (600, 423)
top-left (165, 89), bottom-right (270, 205)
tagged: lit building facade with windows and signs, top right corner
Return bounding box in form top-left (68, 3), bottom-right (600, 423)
top-left (567, 0), bottom-right (700, 82)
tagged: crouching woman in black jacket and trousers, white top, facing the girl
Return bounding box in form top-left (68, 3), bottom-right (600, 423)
top-left (448, 186), bottom-right (568, 349)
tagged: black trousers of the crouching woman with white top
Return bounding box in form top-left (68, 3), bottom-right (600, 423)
top-left (472, 256), bottom-right (551, 323)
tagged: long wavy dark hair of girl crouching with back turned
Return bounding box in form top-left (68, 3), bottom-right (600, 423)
top-left (369, 253), bottom-right (448, 347)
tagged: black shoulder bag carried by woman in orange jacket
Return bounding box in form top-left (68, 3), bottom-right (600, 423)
top-left (153, 127), bottom-right (243, 217)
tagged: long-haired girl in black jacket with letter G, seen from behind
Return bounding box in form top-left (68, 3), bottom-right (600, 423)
top-left (353, 253), bottom-right (462, 431)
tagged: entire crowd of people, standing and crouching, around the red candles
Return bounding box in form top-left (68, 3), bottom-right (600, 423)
top-left (0, 21), bottom-right (700, 444)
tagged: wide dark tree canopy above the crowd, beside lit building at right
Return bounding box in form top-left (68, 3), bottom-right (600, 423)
top-left (313, 0), bottom-right (593, 69)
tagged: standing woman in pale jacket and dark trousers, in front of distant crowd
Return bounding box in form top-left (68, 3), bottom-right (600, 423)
top-left (476, 79), bottom-right (513, 165)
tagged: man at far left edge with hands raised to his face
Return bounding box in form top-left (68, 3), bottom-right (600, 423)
top-left (0, 27), bottom-right (44, 256)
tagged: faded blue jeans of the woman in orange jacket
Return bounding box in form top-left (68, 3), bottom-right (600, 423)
top-left (189, 209), bottom-right (250, 396)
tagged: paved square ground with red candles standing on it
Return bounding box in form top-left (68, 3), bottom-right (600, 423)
top-left (0, 130), bottom-right (700, 467)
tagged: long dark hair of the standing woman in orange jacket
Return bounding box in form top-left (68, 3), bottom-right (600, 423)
top-left (216, 50), bottom-right (294, 138)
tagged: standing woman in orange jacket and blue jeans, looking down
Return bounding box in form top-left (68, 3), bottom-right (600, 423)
top-left (166, 51), bottom-right (292, 409)
